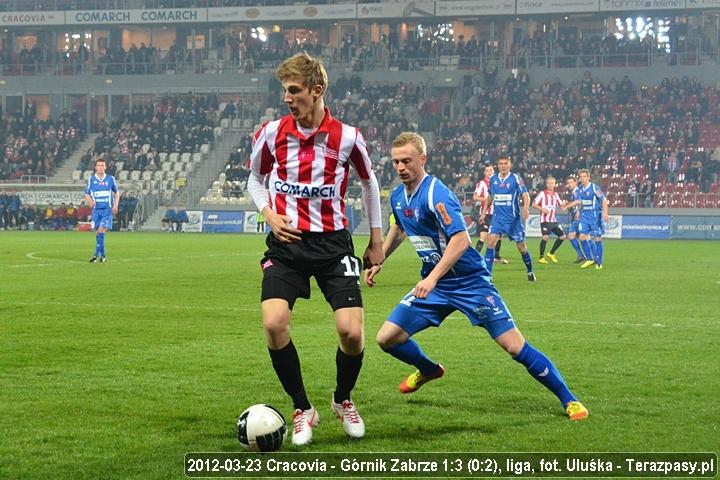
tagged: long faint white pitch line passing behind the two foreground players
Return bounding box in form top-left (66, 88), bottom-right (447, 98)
top-left (0, 300), bottom-right (666, 328)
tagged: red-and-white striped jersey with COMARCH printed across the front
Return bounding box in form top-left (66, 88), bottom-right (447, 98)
top-left (250, 108), bottom-right (372, 232)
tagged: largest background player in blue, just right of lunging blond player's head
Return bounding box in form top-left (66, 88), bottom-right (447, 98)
top-left (483, 157), bottom-right (537, 282)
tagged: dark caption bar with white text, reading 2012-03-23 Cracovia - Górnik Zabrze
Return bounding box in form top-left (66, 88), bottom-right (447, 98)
top-left (185, 452), bottom-right (718, 478)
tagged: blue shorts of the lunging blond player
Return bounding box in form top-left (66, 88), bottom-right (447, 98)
top-left (388, 276), bottom-right (515, 338)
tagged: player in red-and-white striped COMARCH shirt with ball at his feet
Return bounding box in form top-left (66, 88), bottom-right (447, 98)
top-left (248, 53), bottom-right (385, 445)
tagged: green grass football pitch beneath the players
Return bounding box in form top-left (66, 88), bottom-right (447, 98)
top-left (0, 232), bottom-right (720, 478)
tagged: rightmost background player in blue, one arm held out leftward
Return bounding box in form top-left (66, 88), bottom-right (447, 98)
top-left (565, 169), bottom-right (609, 270)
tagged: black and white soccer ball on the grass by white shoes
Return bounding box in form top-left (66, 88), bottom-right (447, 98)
top-left (237, 403), bottom-right (287, 452)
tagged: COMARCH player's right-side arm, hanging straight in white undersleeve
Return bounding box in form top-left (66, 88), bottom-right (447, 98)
top-left (349, 129), bottom-right (385, 268)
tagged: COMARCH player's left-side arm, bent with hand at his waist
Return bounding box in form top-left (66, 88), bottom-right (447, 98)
top-left (247, 124), bottom-right (302, 243)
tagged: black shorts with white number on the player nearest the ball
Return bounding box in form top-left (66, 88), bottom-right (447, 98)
top-left (260, 230), bottom-right (362, 311)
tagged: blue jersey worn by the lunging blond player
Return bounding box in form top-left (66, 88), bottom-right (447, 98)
top-left (390, 175), bottom-right (490, 283)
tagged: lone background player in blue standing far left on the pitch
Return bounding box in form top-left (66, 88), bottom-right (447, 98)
top-left (85, 158), bottom-right (120, 263)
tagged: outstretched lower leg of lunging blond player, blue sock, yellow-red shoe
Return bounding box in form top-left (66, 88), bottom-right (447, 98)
top-left (496, 321), bottom-right (588, 420)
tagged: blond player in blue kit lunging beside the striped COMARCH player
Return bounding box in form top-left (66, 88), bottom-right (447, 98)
top-left (365, 132), bottom-right (588, 420)
